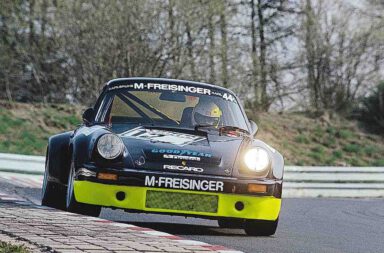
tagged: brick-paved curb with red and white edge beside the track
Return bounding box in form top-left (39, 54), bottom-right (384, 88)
top-left (0, 192), bottom-right (241, 253)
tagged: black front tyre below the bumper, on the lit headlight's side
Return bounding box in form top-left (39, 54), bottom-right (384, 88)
top-left (244, 219), bottom-right (279, 236)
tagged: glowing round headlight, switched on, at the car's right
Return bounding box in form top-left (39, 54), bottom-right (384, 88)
top-left (244, 147), bottom-right (271, 172)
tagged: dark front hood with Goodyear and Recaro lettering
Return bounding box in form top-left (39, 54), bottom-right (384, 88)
top-left (119, 127), bottom-right (243, 176)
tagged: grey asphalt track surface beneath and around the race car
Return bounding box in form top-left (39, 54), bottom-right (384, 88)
top-left (0, 179), bottom-right (384, 253)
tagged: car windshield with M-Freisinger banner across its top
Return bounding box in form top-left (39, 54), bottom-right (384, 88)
top-left (96, 83), bottom-right (248, 132)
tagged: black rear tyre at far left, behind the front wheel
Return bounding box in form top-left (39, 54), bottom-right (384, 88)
top-left (41, 149), bottom-right (65, 210)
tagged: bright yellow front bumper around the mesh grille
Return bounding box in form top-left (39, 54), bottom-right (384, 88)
top-left (74, 181), bottom-right (281, 220)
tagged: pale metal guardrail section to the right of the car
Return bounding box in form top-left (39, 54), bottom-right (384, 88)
top-left (283, 166), bottom-right (384, 198)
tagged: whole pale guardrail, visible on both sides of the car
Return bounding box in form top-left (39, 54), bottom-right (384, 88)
top-left (0, 153), bottom-right (384, 197)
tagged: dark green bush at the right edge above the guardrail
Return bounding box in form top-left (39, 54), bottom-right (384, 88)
top-left (359, 81), bottom-right (384, 134)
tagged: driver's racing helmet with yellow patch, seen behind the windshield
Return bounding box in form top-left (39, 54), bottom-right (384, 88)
top-left (192, 99), bottom-right (222, 127)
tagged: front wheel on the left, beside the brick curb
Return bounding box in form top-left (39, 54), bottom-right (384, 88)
top-left (65, 157), bottom-right (101, 217)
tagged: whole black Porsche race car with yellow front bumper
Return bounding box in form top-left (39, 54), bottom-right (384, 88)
top-left (42, 78), bottom-right (284, 235)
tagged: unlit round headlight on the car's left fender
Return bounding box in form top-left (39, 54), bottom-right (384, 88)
top-left (97, 134), bottom-right (124, 159)
